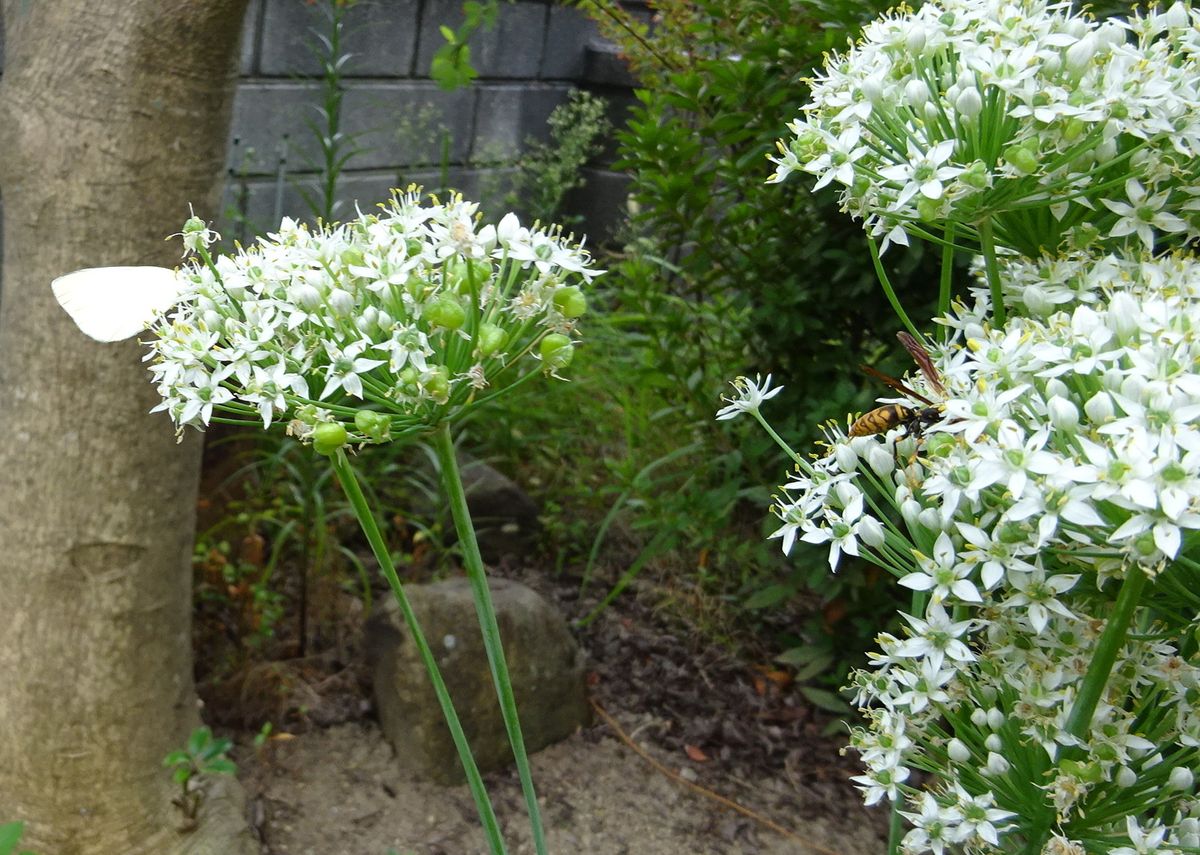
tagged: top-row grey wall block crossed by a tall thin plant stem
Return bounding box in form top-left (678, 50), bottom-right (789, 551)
top-left (260, 0), bottom-right (419, 77)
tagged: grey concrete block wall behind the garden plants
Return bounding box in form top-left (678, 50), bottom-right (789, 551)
top-left (221, 0), bottom-right (632, 239)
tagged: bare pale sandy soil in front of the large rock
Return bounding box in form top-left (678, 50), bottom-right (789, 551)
top-left (242, 721), bottom-right (883, 855)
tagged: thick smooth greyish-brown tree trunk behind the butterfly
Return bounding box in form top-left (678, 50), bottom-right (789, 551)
top-left (0, 0), bottom-right (257, 855)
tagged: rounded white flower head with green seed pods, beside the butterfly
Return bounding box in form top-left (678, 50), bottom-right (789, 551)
top-left (146, 190), bottom-right (600, 441)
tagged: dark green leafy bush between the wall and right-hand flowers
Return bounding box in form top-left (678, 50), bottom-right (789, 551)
top-left (583, 0), bottom-right (936, 437)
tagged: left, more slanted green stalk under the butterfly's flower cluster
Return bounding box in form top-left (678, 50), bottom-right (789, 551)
top-left (330, 449), bottom-right (508, 855)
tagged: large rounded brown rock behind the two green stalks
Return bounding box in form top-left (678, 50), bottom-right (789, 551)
top-left (365, 578), bottom-right (590, 784)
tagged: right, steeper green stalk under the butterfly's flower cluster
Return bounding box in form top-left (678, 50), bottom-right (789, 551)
top-left (433, 421), bottom-right (547, 855)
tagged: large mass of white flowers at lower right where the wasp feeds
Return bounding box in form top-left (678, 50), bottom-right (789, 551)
top-left (775, 256), bottom-right (1200, 853)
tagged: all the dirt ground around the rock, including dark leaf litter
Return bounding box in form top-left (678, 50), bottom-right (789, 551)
top-left (209, 561), bottom-right (886, 855)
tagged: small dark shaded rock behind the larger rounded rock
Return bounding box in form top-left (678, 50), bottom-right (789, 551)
top-left (458, 450), bottom-right (540, 564)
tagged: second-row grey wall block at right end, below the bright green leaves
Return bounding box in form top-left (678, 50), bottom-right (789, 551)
top-left (470, 85), bottom-right (570, 163)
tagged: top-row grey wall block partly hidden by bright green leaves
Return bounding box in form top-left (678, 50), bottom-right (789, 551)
top-left (415, 0), bottom-right (550, 79)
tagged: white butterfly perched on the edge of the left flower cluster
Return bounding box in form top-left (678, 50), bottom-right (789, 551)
top-left (50, 267), bottom-right (182, 341)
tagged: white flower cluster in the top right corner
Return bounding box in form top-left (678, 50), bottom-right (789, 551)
top-left (772, 0), bottom-right (1200, 257)
